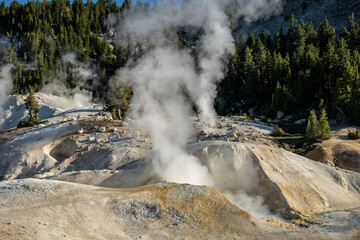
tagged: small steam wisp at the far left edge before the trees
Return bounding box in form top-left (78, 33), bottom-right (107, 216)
top-left (0, 64), bottom-right (14, 112)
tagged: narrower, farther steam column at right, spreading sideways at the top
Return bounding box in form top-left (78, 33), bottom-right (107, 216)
top-left (116, 0), bottom-right (282, 126)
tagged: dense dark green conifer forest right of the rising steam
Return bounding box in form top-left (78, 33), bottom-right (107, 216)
top-left (217, 17), bottom-right (360, 124)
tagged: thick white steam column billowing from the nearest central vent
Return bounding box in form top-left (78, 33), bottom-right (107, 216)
top-left (119, 47), bottom-right (212, 185)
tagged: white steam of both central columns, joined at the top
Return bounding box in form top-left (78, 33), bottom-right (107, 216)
top-left (111, 0), bottom-right (281, 216)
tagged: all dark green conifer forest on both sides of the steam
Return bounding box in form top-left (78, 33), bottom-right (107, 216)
top-left (0, 0), bottom-right (360, 124)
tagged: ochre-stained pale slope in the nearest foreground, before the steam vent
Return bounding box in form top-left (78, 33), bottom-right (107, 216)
top-left (0, 179), bottom-right (359, 239)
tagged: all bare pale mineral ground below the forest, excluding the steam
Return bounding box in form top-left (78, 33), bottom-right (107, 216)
top-left (0, 95), bottom-right (360, 239)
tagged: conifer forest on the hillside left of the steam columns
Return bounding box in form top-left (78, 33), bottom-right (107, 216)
top-left (0, 0), bottom-right (139, 96)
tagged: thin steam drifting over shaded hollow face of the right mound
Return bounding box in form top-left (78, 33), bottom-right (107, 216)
top-left (206, 145), bottom-right (273, 217)
